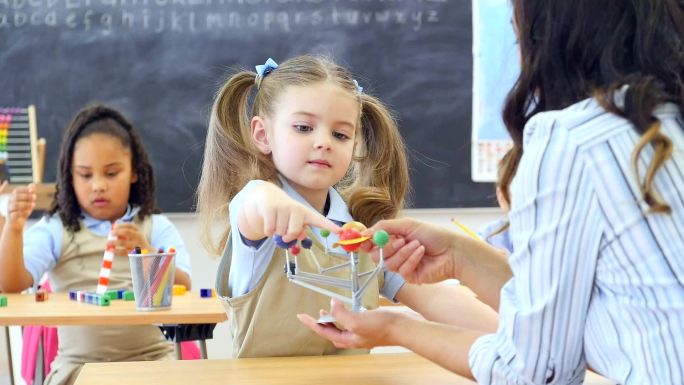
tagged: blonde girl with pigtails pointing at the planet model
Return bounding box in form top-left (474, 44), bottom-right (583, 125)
top-left (198, 55), bottom-right (497, 357)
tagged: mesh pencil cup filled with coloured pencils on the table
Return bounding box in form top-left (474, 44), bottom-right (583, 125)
top-left (128, 252), bottom-right (176, 311)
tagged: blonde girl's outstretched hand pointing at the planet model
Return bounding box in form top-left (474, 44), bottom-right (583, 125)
top-left (238, 183), bottom-right (341, 242)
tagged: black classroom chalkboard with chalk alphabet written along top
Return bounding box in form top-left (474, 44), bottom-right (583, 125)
top-left (0, 0), bottom-right (496, 212)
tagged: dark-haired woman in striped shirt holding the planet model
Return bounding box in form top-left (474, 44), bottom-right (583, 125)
top-left (300, 0), bottom-right (684, 384)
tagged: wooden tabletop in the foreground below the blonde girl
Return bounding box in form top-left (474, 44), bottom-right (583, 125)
top-left (75, 353), bottom-right (611, 385)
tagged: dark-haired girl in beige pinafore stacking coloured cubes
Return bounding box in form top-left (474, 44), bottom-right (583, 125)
top-left (0, 106), bottom-right (190, 385)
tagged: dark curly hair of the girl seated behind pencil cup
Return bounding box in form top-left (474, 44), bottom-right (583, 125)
top-left (48, 105), bottom-right (159, 232)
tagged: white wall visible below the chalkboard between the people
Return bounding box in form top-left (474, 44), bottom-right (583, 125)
top-left (0, 208), bottom-right (503, 385)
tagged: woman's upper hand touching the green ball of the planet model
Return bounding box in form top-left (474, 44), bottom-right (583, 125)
top-left (364, 218), bottom-right (459, 283)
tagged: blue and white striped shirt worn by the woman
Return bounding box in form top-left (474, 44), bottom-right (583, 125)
top-left (470, 99), bottom-right (684, 384)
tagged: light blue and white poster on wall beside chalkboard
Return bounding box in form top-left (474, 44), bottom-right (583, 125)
top-left (471, 0), bottom-right (520, 182)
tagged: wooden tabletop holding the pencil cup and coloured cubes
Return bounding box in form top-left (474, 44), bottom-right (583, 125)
top-left (0, 292), bottom-right (227, 326)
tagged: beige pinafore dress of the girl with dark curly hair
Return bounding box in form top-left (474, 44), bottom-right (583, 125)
top-left (45, 216), bottom-right (174, 385)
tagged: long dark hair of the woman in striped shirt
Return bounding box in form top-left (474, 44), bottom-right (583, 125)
top-left (502, 0), bottom-right (684, 212)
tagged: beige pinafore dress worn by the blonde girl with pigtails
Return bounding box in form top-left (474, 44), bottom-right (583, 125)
top-left (216, 228), bottom-right (383, 358)
